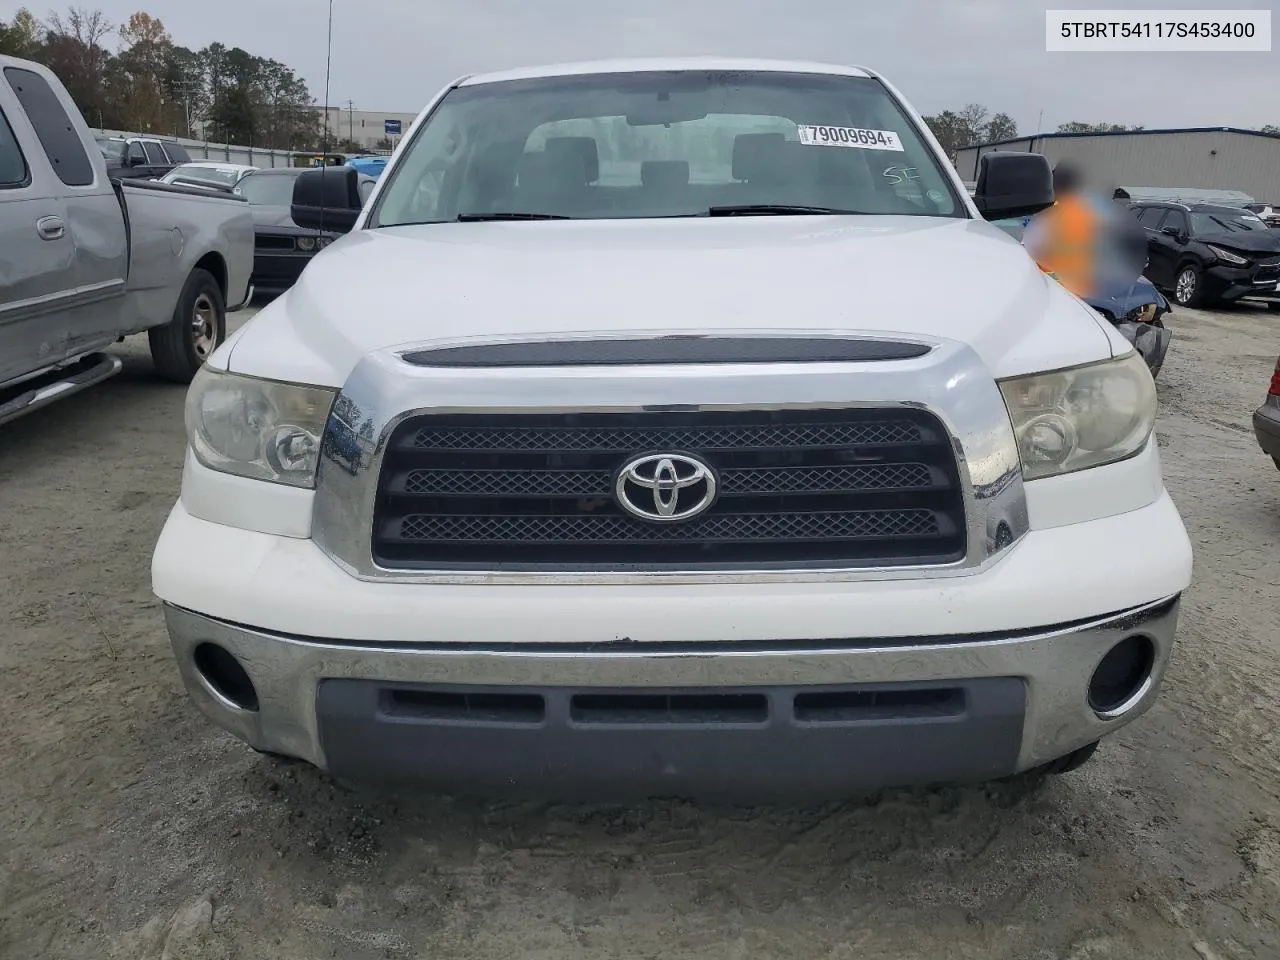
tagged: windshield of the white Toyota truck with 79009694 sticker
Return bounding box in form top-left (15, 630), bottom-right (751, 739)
top-left (371, 70), bottom-right (965, 227)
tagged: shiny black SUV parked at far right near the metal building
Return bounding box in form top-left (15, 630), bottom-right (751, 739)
top-left (1130, 202), bottom-right (1280, 310)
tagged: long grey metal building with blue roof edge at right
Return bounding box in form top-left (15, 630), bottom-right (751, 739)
top-left (956, 127), bottom-right (1280, 204)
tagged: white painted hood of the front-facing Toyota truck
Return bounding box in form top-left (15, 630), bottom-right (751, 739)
top-left (227, 216), bottom-right (1126, 387)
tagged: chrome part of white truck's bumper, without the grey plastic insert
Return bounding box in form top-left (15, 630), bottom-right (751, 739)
top-left (165, 596), bottom-right (1179, 783)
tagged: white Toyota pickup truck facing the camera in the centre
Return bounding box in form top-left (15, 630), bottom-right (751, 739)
top-left (152, 60), bottom-right (1192, 797)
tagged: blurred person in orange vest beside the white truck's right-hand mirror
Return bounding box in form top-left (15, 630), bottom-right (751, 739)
top-left (1023, 163), bottom-right (1116, 298)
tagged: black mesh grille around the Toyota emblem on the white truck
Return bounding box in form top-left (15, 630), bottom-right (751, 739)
top-left (374, 408), bottom-right (965, 570)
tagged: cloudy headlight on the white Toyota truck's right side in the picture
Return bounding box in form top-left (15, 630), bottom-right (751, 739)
top-left (1000, 352), bottom-right (1156, 480)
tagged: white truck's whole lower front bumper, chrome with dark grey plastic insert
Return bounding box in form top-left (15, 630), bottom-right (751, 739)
top-left (165, 598), bottom-right (1178, 799)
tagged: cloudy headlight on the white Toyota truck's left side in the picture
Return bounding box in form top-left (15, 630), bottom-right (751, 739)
top-left (187, 366), bottom-right (338, 486)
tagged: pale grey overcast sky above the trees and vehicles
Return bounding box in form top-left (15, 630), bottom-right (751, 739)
top-left (72, 0), bottom-right (1280, 133)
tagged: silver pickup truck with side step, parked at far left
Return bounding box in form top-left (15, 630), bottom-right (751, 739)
top-left (0, 56), bottom-right (253, 422)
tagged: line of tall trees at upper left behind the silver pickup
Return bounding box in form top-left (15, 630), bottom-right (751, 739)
top-left (0, 6), bottom-right (355, 151)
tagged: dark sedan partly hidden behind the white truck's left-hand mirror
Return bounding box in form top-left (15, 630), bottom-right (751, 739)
top-left (236, 166), bottom-right (374, 297)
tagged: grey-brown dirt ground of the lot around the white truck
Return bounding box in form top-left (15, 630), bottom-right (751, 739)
top-left (0, 302), bottom-right (1280, 960)
